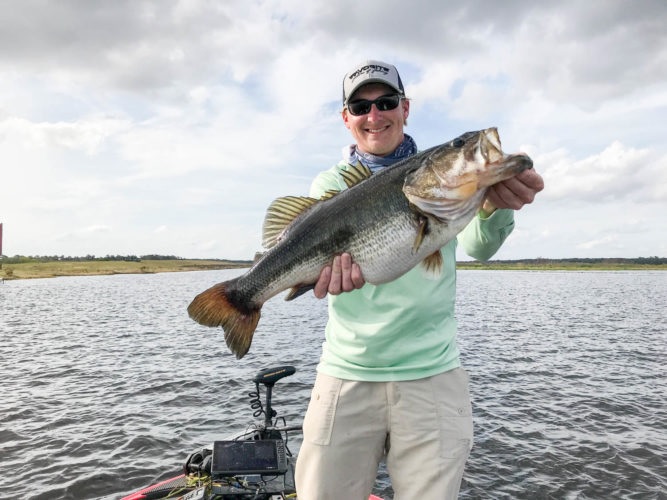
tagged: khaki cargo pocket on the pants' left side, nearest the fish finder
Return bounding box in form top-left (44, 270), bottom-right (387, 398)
top-left (303, 373), bottom-right (343, 446)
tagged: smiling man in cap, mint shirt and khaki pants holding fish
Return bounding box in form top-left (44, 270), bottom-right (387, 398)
top-left (296, 61), bottom-right (543, 500)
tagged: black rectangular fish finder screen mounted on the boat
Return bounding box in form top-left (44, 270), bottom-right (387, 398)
top-left (211, 439), bottom-right (287, 479)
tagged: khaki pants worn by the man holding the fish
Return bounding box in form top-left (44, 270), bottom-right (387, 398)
top-left (296, 368), bottom-right (472, 500)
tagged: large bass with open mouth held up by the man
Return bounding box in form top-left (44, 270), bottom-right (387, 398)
top-left (188, 128), bottom-right (533, 358)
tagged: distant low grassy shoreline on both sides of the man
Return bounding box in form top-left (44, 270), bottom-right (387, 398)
top-left (0, 259), bottom-right (667, 282)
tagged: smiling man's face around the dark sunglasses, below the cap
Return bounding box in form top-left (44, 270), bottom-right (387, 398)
top-left (342, 83), bottom-right (410, 156)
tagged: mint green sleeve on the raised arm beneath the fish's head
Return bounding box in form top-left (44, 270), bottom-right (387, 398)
top-left (457, 209), bottom-right (514, 261)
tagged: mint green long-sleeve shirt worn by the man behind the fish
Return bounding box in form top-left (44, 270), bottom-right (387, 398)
top-left (310, 158), bottom-right (514, 382)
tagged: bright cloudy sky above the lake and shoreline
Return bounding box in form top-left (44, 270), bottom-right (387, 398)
top-left (0, 0), bottom-right (667, 260)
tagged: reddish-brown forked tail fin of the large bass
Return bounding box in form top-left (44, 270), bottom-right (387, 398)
top-left (188, 280), bottom-right (262, 359)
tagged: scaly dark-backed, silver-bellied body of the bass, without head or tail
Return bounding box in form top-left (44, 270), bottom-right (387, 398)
top-left (237, 170), bottom-right (418, 303)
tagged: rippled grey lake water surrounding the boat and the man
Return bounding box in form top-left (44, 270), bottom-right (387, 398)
top-left (0, 270), bottom-right (667, 499)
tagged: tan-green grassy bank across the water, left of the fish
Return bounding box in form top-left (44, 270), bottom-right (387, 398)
top-left (0, 259), bottom-right (250, 280)
